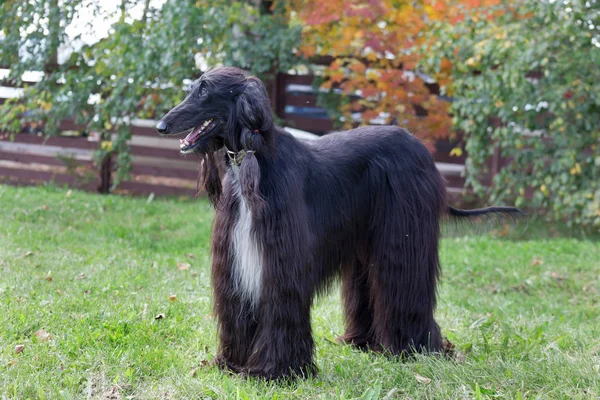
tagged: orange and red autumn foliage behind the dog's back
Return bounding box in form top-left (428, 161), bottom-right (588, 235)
top-left (290, 0), bottom-right (500, 144)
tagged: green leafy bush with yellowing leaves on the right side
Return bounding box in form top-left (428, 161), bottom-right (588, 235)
top-left (424, 0), bottom-right (600, 230)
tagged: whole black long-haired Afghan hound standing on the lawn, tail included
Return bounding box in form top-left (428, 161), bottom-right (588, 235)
top-left (156, 67), bottom-right (520, 379)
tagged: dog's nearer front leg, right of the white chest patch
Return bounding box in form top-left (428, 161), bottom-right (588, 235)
top-left (245, 225), bottom-right (316, 379)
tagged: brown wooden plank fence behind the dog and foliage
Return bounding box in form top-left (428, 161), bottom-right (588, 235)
top-left (0, 74), bottom-right (464, 196)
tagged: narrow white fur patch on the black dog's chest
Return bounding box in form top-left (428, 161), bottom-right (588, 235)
top-left (231, 166), bottom-right (264, 307)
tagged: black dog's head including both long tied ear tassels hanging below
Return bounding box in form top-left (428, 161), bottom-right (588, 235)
top-left (156, 67), bottom-right (274, 213)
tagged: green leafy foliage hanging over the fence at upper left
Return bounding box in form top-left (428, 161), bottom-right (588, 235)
top-left (0, 0), bottom-right (300, 192)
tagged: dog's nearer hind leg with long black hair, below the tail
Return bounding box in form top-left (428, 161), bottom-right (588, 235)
top-left (368, 172), bottom-right (442, 355)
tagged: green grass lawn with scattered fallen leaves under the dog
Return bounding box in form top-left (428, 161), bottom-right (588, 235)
top-left (0, 186), bottom-right (600, 399)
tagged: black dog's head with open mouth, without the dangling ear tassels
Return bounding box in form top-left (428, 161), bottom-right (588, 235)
top-left (156, 67), bottom-right (273, 154)
